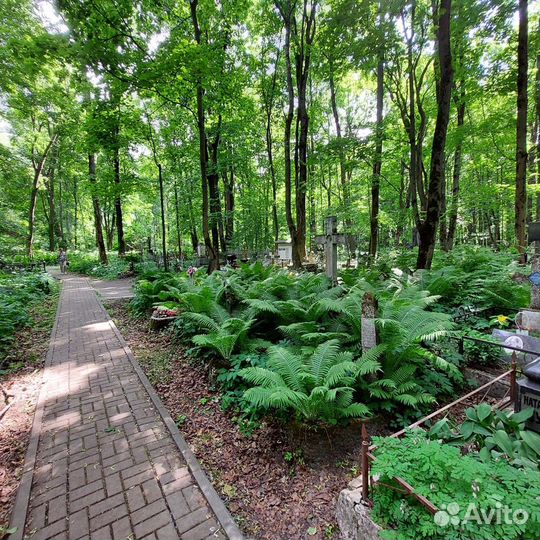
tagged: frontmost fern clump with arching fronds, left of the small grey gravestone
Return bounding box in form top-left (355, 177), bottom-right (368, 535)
top-left (241, 340), bottom-right (379, 424)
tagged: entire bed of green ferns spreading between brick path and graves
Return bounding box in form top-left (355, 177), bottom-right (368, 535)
top-left (127, 248), bottom-right (529, 426)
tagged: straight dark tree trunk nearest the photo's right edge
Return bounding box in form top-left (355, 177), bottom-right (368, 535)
top-left (515, 0), bottom-right (528, 263)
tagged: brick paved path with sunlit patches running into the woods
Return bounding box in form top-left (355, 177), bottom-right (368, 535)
top-left (7, 277), bottom-right (241, 540)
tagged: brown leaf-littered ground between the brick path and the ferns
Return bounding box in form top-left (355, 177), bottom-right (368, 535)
top-left (106, 300), bottom-right (506, 540)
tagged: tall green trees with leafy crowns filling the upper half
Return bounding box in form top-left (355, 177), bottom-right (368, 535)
top-left (0, 0), bottom-right (540, 270)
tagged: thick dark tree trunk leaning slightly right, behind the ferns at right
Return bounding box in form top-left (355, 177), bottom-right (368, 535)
top-left (416, 0), bottom-right (453, 268)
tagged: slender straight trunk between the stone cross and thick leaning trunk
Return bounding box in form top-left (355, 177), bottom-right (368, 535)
top-left (369, 13), bottom-right (384, 258)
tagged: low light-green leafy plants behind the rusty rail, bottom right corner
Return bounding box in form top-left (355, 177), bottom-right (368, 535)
top-left (372, 430), bottom-right (540, 540)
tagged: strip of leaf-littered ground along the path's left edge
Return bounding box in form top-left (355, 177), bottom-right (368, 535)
top-left (0, 295), bottom-right (58, 538)
